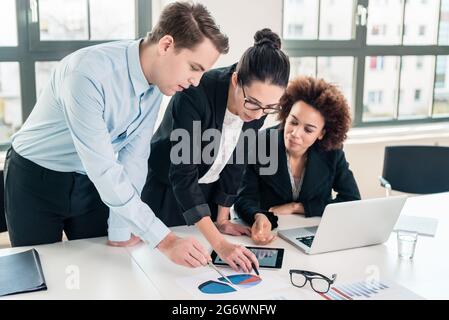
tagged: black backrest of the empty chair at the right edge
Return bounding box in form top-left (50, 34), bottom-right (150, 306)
top-left (382, 146), bottom-right (449, 194)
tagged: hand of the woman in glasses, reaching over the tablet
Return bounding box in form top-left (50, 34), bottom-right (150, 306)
top-left (214, 240), bottom-right (259, 273)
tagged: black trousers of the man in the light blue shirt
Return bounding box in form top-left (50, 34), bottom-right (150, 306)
top-left (4, 148), bottom-right (109, 247)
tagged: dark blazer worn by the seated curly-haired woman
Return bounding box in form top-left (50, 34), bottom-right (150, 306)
top-left (234, 127), bottom-right (360, 229)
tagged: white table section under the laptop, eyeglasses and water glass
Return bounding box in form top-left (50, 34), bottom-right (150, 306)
top-left (128, 193), bottom-right (449, 299)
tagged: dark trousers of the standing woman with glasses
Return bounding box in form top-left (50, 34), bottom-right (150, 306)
top-left (142, 168), bottom-right (218, 227)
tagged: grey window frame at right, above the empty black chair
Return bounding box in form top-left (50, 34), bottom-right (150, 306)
top-left (282, 0), bottom-right (449, 127)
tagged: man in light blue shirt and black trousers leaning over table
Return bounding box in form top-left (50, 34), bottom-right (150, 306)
top-left (5, 3), bottom-right (228, 267)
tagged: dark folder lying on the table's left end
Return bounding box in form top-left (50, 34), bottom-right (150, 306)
top-left (0, 249), bottom-right (47, 296)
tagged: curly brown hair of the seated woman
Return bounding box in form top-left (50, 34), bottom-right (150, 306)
top-left (278, 77), bottom-right (351, 151)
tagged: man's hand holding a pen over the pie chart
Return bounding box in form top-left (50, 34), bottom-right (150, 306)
top-left (157, 233), bottom-right (212, 268)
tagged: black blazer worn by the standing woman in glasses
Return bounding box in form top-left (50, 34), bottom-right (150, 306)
top-left (148, 64), bottom-right (265, 224)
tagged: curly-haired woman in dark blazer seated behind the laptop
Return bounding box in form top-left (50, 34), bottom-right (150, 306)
top-left (234, 77), bottom-right (360, 244)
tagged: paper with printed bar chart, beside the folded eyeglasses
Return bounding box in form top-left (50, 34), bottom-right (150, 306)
top-left (320, 281), bottom-right (423, 300)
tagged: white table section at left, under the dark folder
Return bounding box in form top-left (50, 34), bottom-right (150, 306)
top-left (0, 238), bottom-right (161, 299)
